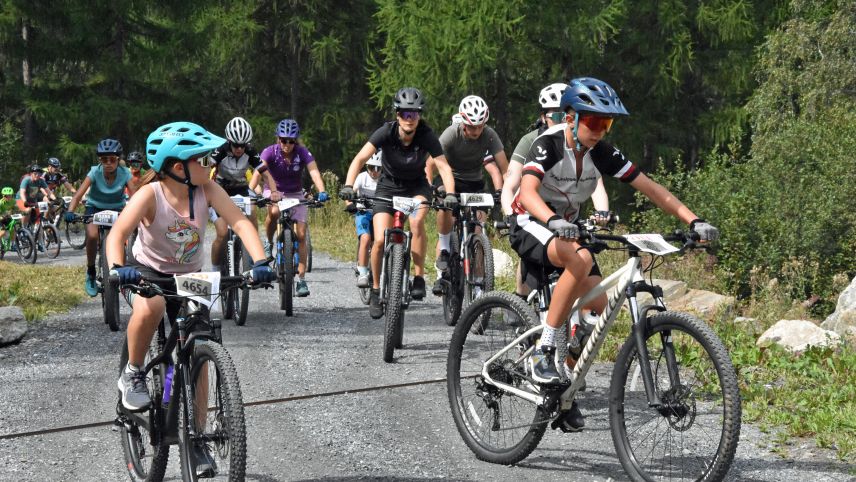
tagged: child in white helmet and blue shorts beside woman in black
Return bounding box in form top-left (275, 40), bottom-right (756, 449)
top-left (345, 151), bottom-right (383, 288)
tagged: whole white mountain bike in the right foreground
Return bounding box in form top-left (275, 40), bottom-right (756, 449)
top-left (447, 219), bottom-right (741, 481)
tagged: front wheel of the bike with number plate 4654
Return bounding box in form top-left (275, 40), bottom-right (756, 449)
top-left (178, 341), bottom-right (247, 481)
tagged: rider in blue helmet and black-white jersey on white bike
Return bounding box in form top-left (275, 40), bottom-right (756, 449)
top-left (510, 77), bottom-right (719, 430)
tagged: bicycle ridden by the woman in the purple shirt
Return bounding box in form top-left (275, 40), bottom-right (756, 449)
top-left (256, 198), bottom-right (324, 316)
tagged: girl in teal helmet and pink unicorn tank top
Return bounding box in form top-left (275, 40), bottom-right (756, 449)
top-left (106, 122), bottom-right (274, 436)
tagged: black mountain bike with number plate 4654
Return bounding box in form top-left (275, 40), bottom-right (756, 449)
top-left (110, 272), bottom-right (262, 481)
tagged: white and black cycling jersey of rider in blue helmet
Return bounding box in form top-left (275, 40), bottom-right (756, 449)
top-left (514, 124), bottom-right (640, 221)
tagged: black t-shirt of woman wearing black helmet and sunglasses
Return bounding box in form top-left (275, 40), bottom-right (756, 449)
top-left (369, 121), bottom-right (443, 181)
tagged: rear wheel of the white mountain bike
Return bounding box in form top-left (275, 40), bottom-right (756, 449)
top-left (446, 292), bottom-right (550, 465)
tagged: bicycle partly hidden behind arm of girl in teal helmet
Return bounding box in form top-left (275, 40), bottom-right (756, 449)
top-left (220, 196), bottom-right (253, 326)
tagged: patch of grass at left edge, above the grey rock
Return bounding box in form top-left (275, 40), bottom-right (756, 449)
top-left (0, 261), bottom-right (85, 321)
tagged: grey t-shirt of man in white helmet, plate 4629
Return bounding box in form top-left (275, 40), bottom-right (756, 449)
top-left (440, 123), bottom-right (503, 181)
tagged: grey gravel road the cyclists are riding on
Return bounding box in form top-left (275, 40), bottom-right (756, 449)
top-left (0, 243), bottom-right (856, 481)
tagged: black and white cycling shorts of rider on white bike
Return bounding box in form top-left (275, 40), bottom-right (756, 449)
top-left (508, 214), bottom-right (601, 289)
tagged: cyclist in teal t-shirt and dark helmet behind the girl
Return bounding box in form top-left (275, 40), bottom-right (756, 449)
top-left (65, 139), bottom-right (134, 296)
